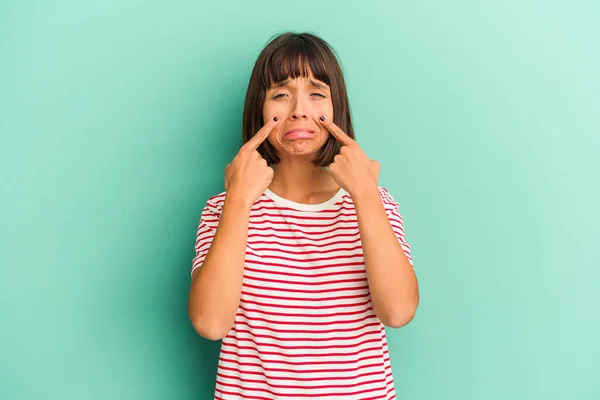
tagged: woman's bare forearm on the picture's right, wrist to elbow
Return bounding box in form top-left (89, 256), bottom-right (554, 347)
top-left (352, 188), bottom-right (419, 327)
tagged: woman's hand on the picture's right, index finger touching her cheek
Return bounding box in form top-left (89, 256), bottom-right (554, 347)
top-left (320, 118), bottom-right (379, 196)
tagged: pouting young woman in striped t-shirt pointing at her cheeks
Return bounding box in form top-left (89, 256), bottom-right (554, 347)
top-left (188, 33), bottom-right (419, 400)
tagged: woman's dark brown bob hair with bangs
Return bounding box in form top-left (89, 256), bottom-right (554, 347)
top-left (242, 32), bottom-right (354, 166)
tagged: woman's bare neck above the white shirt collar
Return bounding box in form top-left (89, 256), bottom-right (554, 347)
top-left (269, 157), bottom-right (340, 204)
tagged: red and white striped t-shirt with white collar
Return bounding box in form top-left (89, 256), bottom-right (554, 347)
top-left (192, 187), bottom-right (414, 400)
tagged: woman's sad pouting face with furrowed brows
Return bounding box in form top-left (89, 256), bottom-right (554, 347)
top-left (263, 74), bottom-right (333, 161)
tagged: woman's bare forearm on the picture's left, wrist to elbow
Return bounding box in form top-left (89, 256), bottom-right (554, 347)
top-left (188, 198), bottom-right (250, 340)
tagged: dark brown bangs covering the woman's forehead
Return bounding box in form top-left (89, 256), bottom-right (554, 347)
top-left (261, 38), bottom-right (331, 90)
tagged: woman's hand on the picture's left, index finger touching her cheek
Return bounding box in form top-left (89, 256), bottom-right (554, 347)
top-left (225, 117), bottom-right (279, 206)
